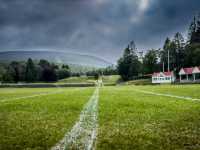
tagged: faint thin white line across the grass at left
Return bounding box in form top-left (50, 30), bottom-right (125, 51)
top-left (0, 91), bottom-right (63, 102)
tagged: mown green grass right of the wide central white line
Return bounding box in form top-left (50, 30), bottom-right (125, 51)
top-left (97, 85), bottom-right (200, 150)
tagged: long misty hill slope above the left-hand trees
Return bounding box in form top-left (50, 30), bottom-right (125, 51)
top-left (0, 51), bottom-right (112, 68)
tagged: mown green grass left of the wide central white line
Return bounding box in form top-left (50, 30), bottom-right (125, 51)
top-left (0, 88), bottom-right (94, 150)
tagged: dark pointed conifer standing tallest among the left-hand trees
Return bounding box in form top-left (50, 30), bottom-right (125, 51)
top-left (25, 58), bottom-right (37, 82)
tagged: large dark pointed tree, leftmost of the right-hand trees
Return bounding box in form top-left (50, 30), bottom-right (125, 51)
top-left (117, 43), bottom-right (140, 81)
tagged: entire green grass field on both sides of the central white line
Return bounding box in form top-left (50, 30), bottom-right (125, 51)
top-left (0, 85), bottom-right (200, 150)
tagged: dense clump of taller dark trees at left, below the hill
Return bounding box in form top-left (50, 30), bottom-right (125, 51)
top-left (0, 58), bottom-right (71, 83)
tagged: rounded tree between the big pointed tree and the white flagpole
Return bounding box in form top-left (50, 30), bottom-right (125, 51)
top-left (143, 49), bottom-right (158, 74)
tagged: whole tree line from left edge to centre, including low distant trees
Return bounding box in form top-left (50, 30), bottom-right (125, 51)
top-left (0, 58), bottom-right (118, 83)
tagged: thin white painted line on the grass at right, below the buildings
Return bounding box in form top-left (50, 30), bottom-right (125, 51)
top-left (135, 90), bottom-right (200, 101)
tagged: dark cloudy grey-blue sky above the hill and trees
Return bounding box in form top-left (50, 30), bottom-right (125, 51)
top-left (0, 0), bottom-right (200, 62)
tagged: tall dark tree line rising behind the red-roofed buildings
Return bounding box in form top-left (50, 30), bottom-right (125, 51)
top-left (117, 15), bottom-right (200, 80)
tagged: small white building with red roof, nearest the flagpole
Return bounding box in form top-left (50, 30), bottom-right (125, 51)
top-left (152, 72), bottom-right (176, 84)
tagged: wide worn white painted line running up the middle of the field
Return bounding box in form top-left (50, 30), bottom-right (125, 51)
top-left (51, 87), bottom-right (99, 150)
